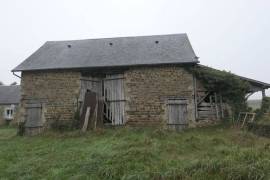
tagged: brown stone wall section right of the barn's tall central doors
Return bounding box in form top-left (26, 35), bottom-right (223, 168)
top-left (125, 67), bottom-right (195, 126)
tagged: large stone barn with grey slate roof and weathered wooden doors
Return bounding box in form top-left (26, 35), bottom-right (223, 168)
top-left (13, 34), bottom-right (270, 132)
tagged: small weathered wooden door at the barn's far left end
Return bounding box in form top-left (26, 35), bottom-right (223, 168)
top-left (25, 103), bottom-right (43, 128)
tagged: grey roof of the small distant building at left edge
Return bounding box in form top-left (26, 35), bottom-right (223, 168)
top-left (0, 85), bottom-right (21, 105)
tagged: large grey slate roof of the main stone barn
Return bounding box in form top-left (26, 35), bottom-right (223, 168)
top-left (12, 34), bottom-right (198, 71)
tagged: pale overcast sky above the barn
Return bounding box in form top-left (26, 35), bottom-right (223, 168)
top-left (0, 0), bottom-right (270, 97)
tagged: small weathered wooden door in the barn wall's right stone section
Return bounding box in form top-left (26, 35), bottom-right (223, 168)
top-left (167, 99), bottom-right (188, 130)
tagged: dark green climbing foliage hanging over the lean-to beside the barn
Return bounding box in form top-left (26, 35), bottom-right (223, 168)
top-left (193, 67), bottom-right (250, 114)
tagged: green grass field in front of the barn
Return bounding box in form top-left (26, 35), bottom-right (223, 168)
top-left (0, 126), bottom-right (270, 180)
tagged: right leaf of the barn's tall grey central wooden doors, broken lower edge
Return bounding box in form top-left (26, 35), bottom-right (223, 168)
top-left (103, 74), bottom-right (125, 125)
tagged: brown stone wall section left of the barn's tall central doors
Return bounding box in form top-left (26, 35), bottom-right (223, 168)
top-left (20, 71), bottom-right (81, 126)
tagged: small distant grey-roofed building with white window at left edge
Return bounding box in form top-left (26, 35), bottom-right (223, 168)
top-left (0, 85), bottom-right (21, 125)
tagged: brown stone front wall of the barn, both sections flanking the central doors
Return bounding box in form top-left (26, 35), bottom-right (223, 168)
top-left (19, 66), bottom-right (198, 131)
